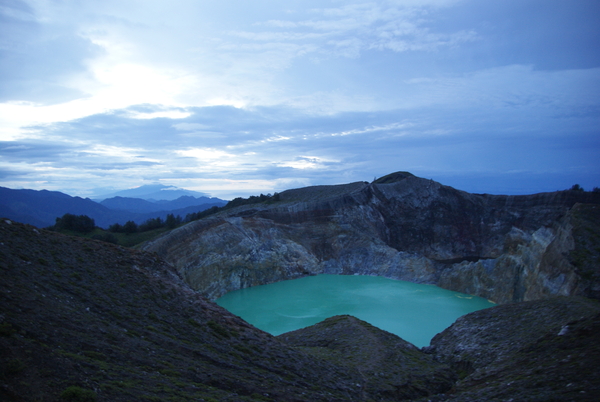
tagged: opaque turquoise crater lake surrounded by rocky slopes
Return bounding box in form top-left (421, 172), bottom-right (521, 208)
top-left (217, 275), bottom-right (494, 347)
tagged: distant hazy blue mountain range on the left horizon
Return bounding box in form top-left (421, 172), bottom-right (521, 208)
top-left (0, 186), bottom-right (227, 228)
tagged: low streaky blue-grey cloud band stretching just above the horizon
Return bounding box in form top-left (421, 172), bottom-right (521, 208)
top-left (0, 90), bottom-right (600, 196)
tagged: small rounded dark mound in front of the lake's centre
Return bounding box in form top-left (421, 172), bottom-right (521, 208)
top-left (278, 316), bottom-right (458, 401)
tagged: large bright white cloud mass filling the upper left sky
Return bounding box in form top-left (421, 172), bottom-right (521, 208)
top-left (0, 1), bottom-right (482, 127)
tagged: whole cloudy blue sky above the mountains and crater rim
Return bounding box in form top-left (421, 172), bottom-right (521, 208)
top-left (0, 0), bottom-right (600, 199)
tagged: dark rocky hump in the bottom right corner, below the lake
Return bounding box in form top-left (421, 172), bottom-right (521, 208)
top-left (425, 297), bottom-right (600, 401)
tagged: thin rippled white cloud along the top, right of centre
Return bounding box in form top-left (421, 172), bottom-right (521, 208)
top-left (231, 2), bottom-right (477, 58)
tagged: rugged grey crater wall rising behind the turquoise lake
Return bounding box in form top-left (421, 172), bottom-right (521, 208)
top-left (144, 172), bottom-right (600, 303)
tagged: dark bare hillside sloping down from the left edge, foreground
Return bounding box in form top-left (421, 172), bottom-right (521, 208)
top-left (0, 220), bottom-right (376, 401)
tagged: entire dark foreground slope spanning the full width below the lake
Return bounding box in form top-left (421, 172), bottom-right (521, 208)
top-left (0, 219), bottom-right (600, 401)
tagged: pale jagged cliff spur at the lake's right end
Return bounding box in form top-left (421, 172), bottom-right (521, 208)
top-left (438, 204), bottom-right (600, 303)
